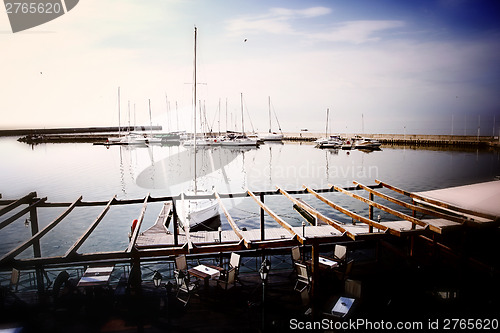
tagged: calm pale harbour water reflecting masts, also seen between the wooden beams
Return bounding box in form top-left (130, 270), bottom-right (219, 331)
top-left (0, 138), bottom-right (500, 256)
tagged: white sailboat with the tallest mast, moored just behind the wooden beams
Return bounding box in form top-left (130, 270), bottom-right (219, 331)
top-left (177, 27), bottom-right (220, 230)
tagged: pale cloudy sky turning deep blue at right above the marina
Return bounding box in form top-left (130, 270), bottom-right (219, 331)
top-left (0, 0), bottom-right (500, 135)
